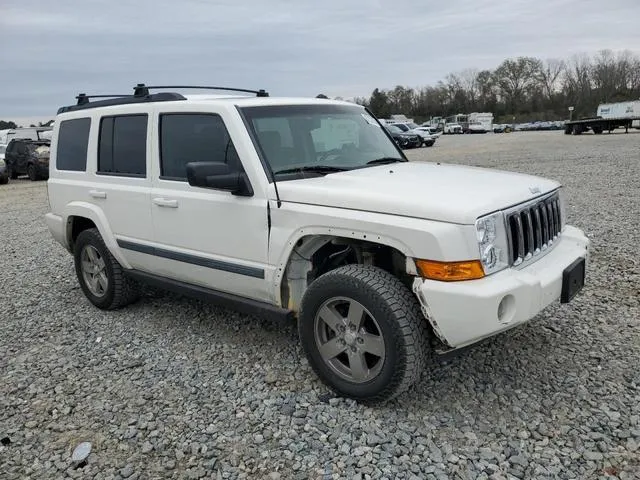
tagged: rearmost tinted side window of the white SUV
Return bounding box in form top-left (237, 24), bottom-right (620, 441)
top-left (56, 118), bottom-right (91, 172)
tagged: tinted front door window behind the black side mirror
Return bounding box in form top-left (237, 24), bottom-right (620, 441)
top-left (160, 113), bottom-right (240, 180)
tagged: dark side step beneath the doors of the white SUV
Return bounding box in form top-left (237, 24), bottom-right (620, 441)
top-left (126, 270), bottom-right (294, 322)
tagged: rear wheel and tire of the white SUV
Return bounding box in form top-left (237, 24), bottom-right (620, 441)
top-left (73, 228), bottom-right (140, 310)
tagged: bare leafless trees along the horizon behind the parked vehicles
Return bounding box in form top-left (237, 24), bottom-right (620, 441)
top-left (354, 50), bottom-right (640, 123)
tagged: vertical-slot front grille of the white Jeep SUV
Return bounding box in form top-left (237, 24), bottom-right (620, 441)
top-left (506, 192), bottom-right (562, 266)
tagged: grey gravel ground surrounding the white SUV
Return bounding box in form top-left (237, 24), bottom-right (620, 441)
top-left (0, 132), bottom-right (640, 479)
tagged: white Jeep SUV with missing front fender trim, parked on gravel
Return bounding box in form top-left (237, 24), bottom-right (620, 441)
top-left (46, 85), bottom-right (589, 403)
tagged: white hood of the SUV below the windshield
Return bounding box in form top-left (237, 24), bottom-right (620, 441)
top-left (278, 162), bottom-right (560, 224)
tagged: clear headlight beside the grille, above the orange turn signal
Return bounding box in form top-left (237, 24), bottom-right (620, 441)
top-left (476, 212), bottom-right (509, 275)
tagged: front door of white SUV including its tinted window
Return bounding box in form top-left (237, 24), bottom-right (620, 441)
top-left (151, 107), bottom-right (271, 300)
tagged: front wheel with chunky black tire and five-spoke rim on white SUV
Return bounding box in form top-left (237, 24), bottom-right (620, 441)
top-left (298, 265), bottom-right (428, 404)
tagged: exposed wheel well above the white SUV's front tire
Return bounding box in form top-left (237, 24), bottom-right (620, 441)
top-left (280, 235), bottom-right (413, 312)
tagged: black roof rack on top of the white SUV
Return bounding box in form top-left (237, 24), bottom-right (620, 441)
top-left (58, 83), bottom-right (269, 114)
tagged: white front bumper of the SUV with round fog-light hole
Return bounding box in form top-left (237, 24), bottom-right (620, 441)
top-left (413, 226), bottom-right (590, 348)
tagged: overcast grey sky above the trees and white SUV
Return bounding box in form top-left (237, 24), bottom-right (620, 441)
top-left (0, 0), bottom-right (640, 124)
